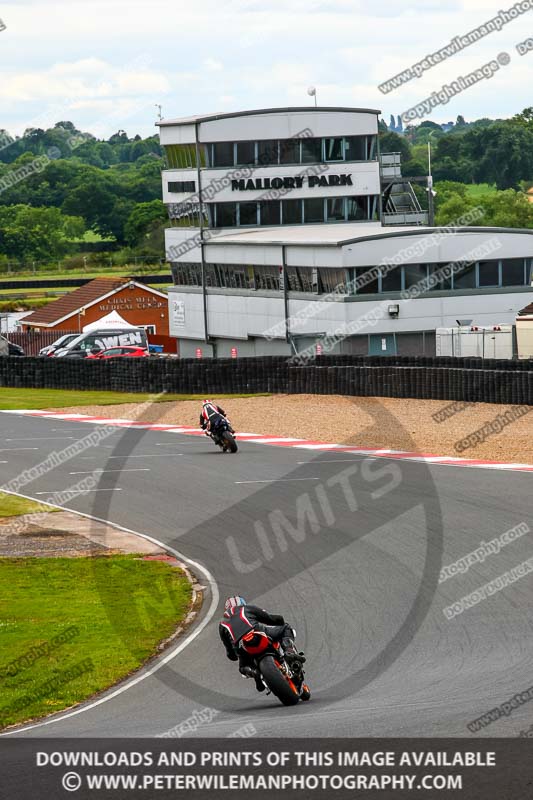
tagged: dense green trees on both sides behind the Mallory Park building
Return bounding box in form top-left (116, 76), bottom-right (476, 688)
top-left (0, 108), bottom-right (533, 262)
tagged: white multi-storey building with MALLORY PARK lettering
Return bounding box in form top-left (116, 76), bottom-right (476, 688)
top-left (160, 107), bottom-right (533, 357)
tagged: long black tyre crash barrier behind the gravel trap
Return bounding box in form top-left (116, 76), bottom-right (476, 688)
top-left (0, 356), bottom-right (533, 405)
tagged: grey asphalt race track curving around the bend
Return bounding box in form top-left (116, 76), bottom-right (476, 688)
top-left (0, 414), bottom-right (533, 737)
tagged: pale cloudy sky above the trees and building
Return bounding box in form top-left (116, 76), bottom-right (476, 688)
top-left (0, 0), bottom-right (533, 138)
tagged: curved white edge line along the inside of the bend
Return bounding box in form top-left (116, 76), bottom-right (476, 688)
top-left (0, 490), bottom-right (220, 736)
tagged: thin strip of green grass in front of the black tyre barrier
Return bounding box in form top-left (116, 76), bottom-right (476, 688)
top-left (0, 387), bottom-right (269, 411)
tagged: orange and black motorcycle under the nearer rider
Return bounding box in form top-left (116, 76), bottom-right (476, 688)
top-left (239, 630), bottom-right (311, 706)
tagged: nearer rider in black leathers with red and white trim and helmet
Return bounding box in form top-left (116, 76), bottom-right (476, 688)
top-left (218, 596), bottom-right (305, 692)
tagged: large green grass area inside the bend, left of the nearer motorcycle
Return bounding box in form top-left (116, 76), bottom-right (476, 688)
top-left (0, 556), bottom-right (191, 727)
